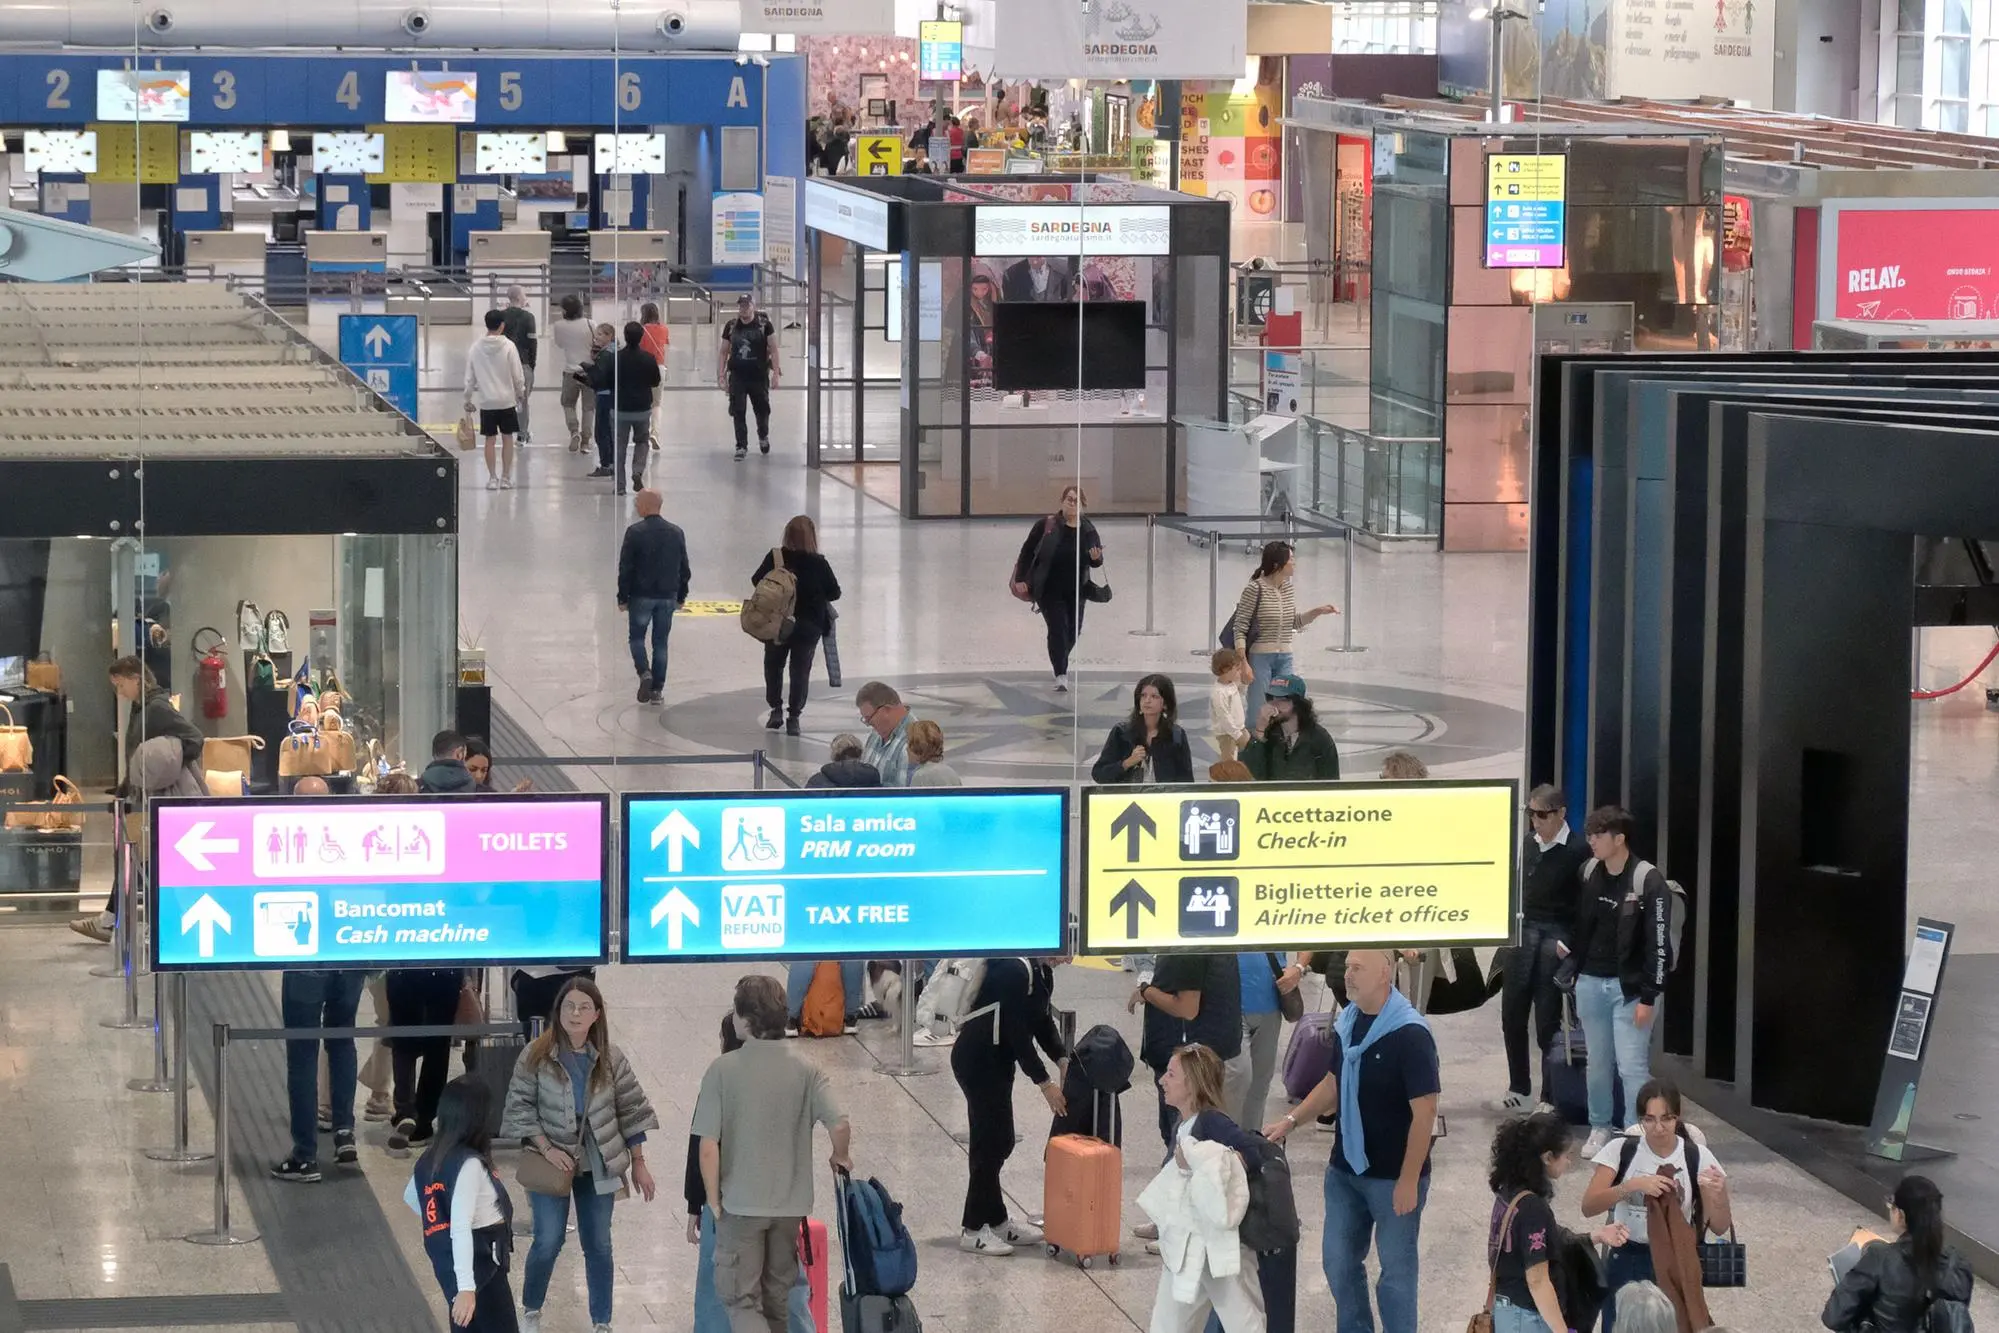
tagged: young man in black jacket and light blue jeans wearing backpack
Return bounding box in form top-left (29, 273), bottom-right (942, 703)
top-left (1573, 805), bottom-right (1671, 1159)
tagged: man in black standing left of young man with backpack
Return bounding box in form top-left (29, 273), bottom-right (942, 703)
top-left (1499, 783), bottom-right (1589, 1115)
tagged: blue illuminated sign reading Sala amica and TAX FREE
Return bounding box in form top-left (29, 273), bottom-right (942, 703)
top-left (624, 787), bottom-right (1069, 963)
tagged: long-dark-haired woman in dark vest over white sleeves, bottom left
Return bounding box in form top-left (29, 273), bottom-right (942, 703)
top-left (402, 1075), bottom-right (520, 1333)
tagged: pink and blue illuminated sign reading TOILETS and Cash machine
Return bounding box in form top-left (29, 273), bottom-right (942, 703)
top-left (152, 795), bottom-right (610, 971)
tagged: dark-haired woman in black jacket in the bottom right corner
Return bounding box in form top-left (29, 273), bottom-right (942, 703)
top-left (1819, 1175), bottom-right (1971, 1333)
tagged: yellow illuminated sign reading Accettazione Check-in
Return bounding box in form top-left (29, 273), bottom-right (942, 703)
top-left (1079, 779), bottom-right (1519, 953)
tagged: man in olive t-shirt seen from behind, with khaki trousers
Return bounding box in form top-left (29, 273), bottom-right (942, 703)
top-left (694, 975), bottom-right (854, 1333)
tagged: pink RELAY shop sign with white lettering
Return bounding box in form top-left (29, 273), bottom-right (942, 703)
top-left (1819, 200), bottom-right (1999, 320)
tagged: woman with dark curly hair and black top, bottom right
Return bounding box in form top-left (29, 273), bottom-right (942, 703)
top-left (1485, 1111), bottom-right (1627, 1333)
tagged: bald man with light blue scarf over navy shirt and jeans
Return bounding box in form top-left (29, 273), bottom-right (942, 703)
top-left (1263, 949), bottom-right (1441, 1333)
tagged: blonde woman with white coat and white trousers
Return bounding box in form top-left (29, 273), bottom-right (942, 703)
top-left (1137, 1045), bottom-right (1263, 1333)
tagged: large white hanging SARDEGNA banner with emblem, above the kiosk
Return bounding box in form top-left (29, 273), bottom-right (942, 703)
top-left (994, 0), bottom-right (1249, 80)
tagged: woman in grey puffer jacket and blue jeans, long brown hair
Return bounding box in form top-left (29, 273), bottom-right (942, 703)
top-left (500, 977), bottom-right (660, 1333)
